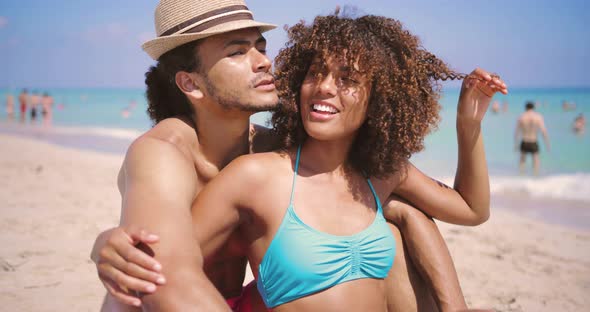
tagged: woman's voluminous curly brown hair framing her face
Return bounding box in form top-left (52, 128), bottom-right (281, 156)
top-left (271, 11), bottom-right (465, 178)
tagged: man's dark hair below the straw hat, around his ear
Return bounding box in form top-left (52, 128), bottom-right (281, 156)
top-left (145, 41), bottom-right (200, 124)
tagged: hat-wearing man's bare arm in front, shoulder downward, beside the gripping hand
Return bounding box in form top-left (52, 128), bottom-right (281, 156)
top-left (121, 137), bottom-right (225, 311)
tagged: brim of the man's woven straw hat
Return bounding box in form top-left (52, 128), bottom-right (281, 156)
top-left (141, 20), bottom-right (277, 60)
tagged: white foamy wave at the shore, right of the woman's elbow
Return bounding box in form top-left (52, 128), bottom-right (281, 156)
top-left (441, 173), bottom-right (590, 203)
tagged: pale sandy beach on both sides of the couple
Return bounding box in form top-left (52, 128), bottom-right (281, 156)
top-left (0, 134), bottom-right (590, 311)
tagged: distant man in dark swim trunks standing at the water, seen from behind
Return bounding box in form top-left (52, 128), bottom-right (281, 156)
top-left (514, 101), bottom-right (550, 174)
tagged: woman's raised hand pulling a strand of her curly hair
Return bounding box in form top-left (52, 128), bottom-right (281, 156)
top-left (457, 68), bottom-right (508, 122)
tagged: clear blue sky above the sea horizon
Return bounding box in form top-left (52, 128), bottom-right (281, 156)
top-left (0, 0), bottom-right (590, 88)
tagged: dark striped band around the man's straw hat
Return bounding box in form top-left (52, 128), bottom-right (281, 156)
top-left (159, 5), bottom-right (252, 37)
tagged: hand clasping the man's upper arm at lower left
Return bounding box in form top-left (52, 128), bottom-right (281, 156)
top-left (90, 227), bottom-right (166, 306)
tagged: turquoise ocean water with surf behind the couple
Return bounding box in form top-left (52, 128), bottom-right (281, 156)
top-left (0, 88), bottom-right (590, 210)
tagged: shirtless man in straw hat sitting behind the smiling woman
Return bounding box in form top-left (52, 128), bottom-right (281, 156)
top-left (92, 0), bottom-right (472, 311)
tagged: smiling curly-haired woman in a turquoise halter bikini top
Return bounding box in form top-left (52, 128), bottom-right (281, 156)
top-left (93, 10), bottom-right (507, 311)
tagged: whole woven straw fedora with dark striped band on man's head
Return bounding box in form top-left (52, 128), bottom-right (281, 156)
top-left (141, 0), bottom-right (276, 60)
